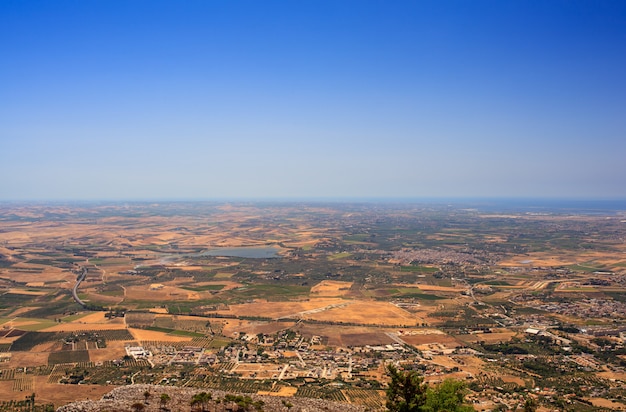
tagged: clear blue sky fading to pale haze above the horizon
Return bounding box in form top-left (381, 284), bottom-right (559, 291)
top-left (0, 0), bottom-right (626, 200)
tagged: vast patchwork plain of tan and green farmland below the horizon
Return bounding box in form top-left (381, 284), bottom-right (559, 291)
top-left (0, 202), bottom-right (626, 410)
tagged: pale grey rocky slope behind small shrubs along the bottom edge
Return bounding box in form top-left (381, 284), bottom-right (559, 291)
top-left (57, 385), bottom-right (369, 412)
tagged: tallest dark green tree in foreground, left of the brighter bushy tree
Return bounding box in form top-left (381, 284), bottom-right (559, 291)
top-left (385, 365), bottom-right (427, 412)
